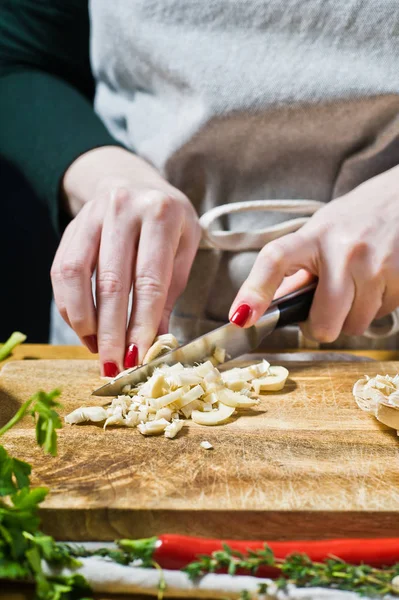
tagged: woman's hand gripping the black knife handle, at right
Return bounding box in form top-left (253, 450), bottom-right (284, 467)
top-left (229, 167), bottom-right (399, 343)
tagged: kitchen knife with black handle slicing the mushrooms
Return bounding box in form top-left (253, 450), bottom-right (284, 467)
top-left (93, 282), bottom-right (317, 396)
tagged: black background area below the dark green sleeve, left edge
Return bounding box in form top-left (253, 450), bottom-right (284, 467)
top-left (0, 156), bottom-right (57, 343)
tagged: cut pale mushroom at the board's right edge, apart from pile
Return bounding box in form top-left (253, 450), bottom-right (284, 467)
top-left (353, 375), bottom-right (399, 431)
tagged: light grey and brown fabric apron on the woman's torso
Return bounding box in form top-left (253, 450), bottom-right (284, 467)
top-left (85, 0), bottom-right (399, 347)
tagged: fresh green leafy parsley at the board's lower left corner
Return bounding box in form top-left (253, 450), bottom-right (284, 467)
top-left (0, 390), bottom-right (90, 600)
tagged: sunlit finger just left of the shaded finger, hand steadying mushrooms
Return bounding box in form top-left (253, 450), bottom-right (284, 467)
top-left (126, 211), bottom-right (181, 362)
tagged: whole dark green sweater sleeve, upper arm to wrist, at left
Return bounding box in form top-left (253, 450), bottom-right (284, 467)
top-left (0, 0), bottom-right (120, 229)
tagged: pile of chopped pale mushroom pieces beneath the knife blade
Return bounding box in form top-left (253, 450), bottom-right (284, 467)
top-left (65, 334), bottom-right (288, 438)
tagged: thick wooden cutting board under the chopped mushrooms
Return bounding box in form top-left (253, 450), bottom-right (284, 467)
top-left (0, 355), bottom-right (399, 540)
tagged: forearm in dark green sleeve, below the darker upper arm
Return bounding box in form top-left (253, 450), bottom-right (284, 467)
top-left (0, 70), bottom-right (123, 232)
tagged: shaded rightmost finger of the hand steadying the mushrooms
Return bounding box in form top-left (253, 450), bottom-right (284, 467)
top-left (158, 225), bottom-right (201, 335)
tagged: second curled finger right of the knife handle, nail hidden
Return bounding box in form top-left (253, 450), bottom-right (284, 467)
top-left (342, 277), bottom-right (384, 335)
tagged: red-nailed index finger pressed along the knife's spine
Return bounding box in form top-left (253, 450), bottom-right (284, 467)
top-left (229, 232), bottom-right (317, 327)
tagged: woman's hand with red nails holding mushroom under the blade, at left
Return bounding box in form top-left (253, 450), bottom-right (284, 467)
top-left (51, 146), bottom-right (201, 377)
